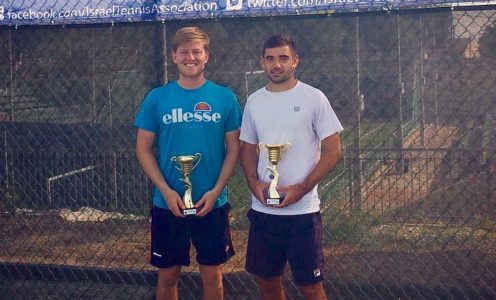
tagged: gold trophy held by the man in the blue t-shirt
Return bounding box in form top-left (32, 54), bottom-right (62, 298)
top-left (171, 153), bottom-right (201, 216)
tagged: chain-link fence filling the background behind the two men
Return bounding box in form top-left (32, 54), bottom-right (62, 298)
top-left (0, 1), bottom-right (496, 299)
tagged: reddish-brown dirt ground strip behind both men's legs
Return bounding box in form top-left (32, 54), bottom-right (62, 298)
top-left (0, 211), bottom-right (496, 295)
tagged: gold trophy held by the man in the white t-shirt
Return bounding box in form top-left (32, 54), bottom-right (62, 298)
top-left (258, 143), bottom-right (291, 205)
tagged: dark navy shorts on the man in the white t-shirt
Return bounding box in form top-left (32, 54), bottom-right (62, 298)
top-left (246, 209), bottom-right (324, 286)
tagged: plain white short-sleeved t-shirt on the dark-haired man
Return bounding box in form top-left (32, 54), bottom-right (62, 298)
top-left (240, 81), bottom-right (343, 215)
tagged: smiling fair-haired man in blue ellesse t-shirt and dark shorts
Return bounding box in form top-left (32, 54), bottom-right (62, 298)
top-left (134, 27), bottom-right (241, 299)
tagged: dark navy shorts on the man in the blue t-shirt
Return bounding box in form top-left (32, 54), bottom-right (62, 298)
top-left (150, 203), bottom-right (234, 268)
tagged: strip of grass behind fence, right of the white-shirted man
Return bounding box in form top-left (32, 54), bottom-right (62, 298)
top-left (323, 205), bottom-right (496, 251)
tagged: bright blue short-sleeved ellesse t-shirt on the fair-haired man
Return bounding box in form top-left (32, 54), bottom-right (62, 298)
top-left (134, 80), bottom-right (241, 208)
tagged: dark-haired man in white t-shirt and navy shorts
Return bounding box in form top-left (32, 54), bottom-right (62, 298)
top-left (240, 34), bottom-right (343, 299)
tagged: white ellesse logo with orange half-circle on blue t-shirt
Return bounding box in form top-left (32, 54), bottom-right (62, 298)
top-left (162, 102), bottom-right (221, 124)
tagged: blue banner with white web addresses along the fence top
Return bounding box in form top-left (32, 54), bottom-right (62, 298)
top-left (0, 0), bottom-right (496, 25)
